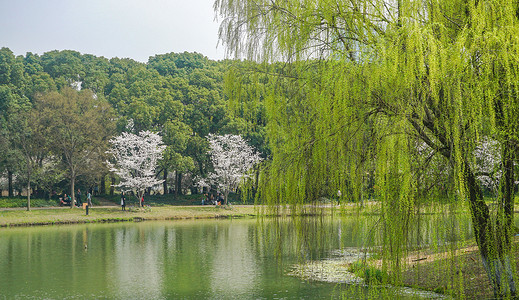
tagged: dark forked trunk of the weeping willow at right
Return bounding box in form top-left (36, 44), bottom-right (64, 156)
top-left (465, 159), bottom-right (517, 297)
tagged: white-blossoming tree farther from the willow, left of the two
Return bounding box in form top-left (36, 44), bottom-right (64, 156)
top-left (107, 131), bottom-right (166, 205)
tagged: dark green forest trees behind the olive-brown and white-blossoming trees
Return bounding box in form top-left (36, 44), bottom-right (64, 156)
top-left (0, 48), bottom-right (265, 202)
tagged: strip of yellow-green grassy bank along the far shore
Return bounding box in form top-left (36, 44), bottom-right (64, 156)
top-left (0, 205), bottom-right (258, 227)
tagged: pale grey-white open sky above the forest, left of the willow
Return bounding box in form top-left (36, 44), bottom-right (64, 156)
top-left (0, 0), bottom-right (225, 62)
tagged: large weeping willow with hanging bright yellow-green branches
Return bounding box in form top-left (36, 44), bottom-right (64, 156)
top-left (215, 0), bottom-right (519, 296)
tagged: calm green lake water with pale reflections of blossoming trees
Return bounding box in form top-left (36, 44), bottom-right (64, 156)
top-left (0, 212), bottom-right (480, 299)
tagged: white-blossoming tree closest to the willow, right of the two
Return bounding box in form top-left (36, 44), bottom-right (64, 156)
top-left (202, 134), bottom-right (261, 204)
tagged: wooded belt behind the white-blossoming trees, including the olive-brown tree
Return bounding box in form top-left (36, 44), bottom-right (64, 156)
top-left (0, 48), bottom-right (268, 197)
